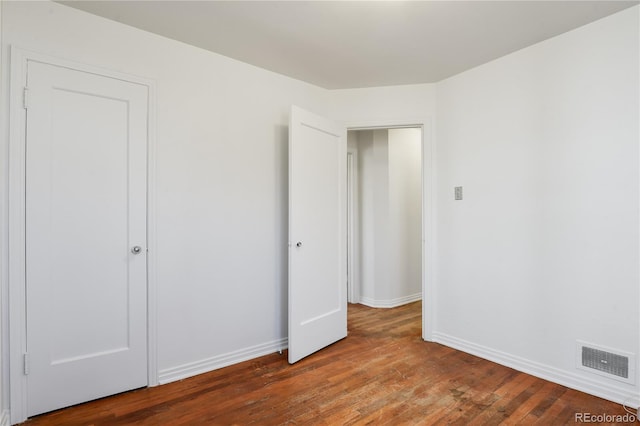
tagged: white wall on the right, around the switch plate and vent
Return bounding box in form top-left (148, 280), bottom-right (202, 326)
top-left (436, 6), bottom-right (640, 405)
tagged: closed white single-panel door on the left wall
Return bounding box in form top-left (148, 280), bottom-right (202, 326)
top-left (25, 61), bottom-right (148, 416)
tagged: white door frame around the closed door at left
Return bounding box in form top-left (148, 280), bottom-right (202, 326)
top-left (2, 46), bottom-right (158, 424)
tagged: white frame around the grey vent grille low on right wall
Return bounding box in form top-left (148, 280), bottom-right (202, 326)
top-left (577, 342), bottom-right (635, 383)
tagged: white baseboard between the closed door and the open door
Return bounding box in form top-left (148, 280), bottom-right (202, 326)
top-left (158, 338), bottom-right (288, 385)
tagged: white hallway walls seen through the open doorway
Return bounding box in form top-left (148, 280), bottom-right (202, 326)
top-left (347, 126), bottom-right (424, 314)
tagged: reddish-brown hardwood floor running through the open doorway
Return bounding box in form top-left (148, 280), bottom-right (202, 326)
top-left (26, 302), bottom-right (637, 426)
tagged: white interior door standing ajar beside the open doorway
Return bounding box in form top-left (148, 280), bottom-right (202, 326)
top-left (289, 107), bottom-right (347, 363)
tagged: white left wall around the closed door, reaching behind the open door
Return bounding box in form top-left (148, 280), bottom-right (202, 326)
top-left (0, 2), bottom-right (328, 406)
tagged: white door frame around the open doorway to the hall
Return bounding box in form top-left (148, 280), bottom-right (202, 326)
top-left (345, 117), bottom-right (437, 342)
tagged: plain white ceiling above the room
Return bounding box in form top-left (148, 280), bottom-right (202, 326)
top-left (59, 0), bottom-right (639, 89)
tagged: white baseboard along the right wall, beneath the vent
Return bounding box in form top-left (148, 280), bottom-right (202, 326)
top-left (433, 332), bottom-right (640, 409)
